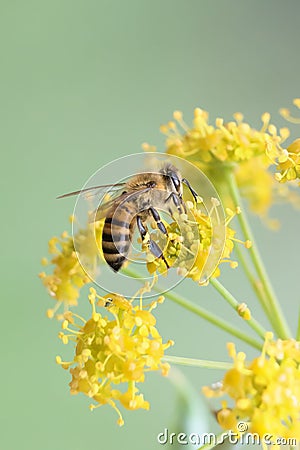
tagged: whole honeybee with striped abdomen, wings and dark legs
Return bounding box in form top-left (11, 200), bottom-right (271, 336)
top-left (58, 164), bottom-right (198, 272)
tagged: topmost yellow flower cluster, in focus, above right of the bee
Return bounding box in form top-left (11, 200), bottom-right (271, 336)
top-left (161, 108), bottom-right (289, 165)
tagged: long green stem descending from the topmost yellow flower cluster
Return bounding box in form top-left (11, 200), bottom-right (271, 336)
top-left (225, 170), bottom-right (291, 339)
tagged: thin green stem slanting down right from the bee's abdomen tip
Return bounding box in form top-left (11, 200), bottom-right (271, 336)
top-left (123, 268), bottom-right (262, 350)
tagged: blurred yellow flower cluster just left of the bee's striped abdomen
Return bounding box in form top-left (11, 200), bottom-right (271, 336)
top-left (39, 217), bottom-right (103, 318)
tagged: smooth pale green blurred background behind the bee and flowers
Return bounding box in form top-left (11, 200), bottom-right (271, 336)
top-left (0, 0), bottom-right (300, 450)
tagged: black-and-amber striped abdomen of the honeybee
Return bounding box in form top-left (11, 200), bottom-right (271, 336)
top-left (102, 203), bottom-right (135, 272)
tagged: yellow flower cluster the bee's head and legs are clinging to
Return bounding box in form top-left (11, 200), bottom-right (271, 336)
top-left (146, 199), bottom-right (251, 284)
